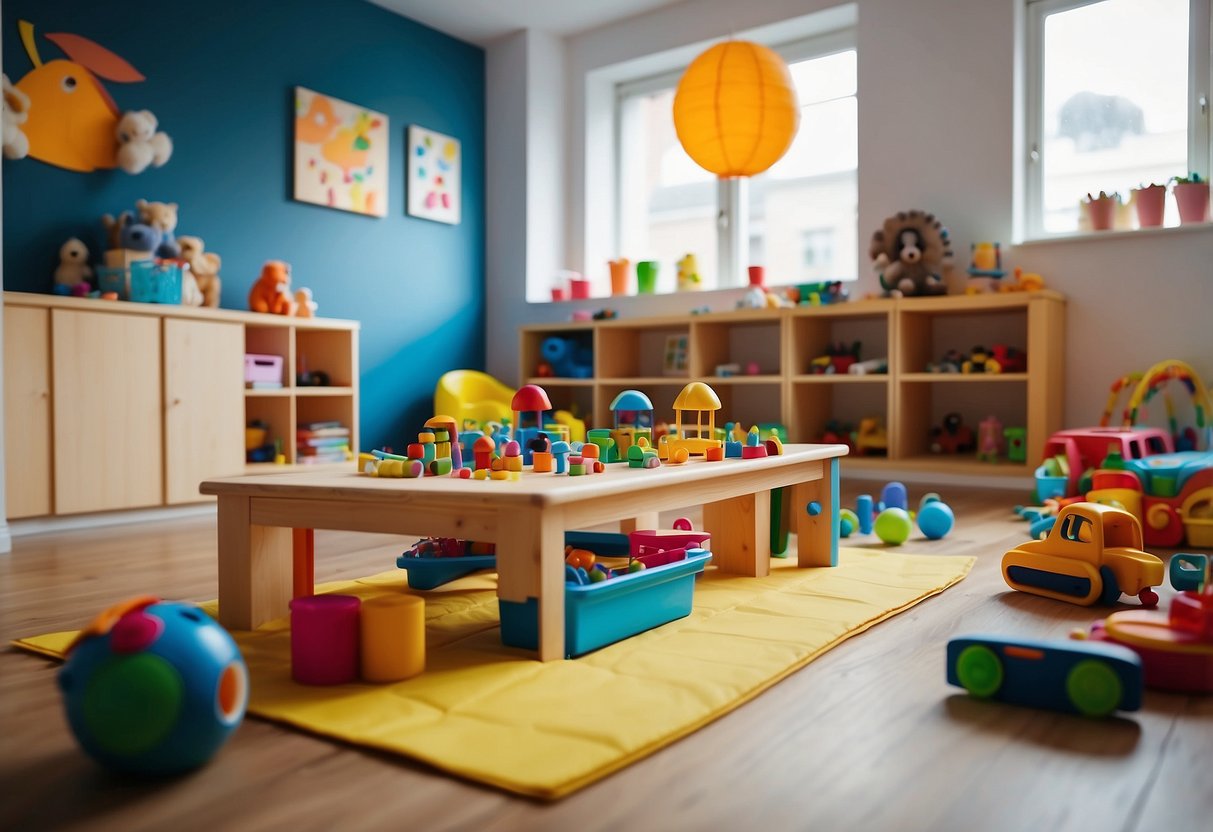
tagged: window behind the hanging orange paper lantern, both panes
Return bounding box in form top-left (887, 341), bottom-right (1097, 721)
top-left (616, 30), bottom-right (859, 292)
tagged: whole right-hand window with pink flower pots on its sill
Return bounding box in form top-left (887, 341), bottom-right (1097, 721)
top-left (1024, 0), bottom-right (1211, 237)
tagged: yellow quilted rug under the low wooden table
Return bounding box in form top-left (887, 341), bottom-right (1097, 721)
top-left (17, 548), bottom-right (973, 799)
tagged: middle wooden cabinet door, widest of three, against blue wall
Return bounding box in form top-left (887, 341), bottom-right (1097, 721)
top-left (51, 309), bottom-right (164, 514)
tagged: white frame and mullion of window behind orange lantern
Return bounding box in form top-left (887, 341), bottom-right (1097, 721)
top-left (611, 24), bottom-right (859, 290)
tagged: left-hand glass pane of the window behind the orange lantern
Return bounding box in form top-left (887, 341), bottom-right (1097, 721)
top-left (619, 87), bottom-right (717, 292)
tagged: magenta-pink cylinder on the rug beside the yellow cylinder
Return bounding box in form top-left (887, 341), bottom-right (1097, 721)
top-left (291, 595), bottom-right (361, 685)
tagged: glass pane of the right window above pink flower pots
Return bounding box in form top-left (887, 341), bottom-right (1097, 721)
top-left (1041, 0), bottom-right (1188, 232)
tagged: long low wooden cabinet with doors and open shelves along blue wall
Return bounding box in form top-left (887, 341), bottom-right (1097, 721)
top-left (4, 292), bottom-right (358, 519)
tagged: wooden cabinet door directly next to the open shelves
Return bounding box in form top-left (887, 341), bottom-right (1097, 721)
top-left (164, 319), bottom-right (244, 505)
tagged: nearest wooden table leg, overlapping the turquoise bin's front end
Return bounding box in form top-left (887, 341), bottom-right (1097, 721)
top-left (497, 508), bottom-right (564, 661)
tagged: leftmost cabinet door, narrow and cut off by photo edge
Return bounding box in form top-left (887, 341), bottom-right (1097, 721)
top-left (4, 307), bottom-right (51, 519)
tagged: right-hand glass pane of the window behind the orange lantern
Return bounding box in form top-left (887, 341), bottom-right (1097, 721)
top-left (750, 50), bottom-right (859, 285)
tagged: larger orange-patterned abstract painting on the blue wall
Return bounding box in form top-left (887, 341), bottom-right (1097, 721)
top-left (295, 86), bottom-right (388, 217)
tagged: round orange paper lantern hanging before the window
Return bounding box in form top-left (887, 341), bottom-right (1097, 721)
top-left (674, 40), bottom-right (801, 177)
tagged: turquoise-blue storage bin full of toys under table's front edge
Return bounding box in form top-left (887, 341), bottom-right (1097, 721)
top-left (497, 549), bottom-right (712, 659)
